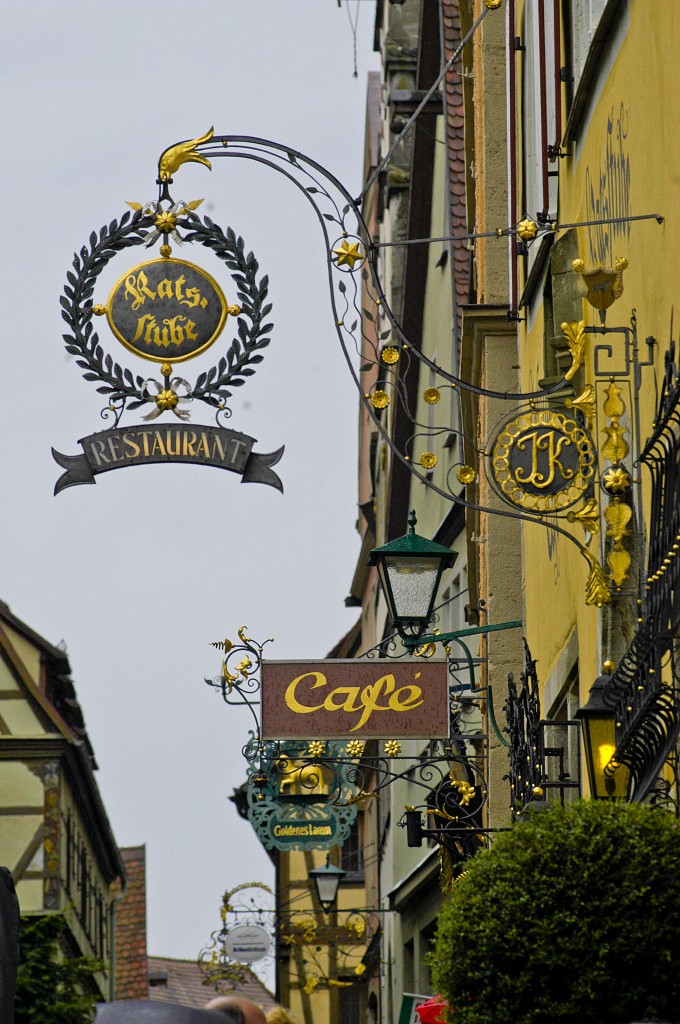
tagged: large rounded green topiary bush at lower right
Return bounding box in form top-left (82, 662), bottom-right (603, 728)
top-left (428, 801), bottom-right (680, 1024)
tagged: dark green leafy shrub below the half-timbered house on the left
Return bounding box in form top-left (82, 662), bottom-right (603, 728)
top-left (14, 914), bottom-right (103, 1024)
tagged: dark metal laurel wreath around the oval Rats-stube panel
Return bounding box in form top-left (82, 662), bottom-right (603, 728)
top-left (60, 210), bottom-right (273, 412)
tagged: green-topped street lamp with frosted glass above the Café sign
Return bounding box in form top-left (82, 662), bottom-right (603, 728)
top-left (367, 510), bottom-right (458, 646)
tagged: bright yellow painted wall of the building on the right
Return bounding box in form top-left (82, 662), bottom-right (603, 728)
top-left (518, 3), bottom-right (680, 749)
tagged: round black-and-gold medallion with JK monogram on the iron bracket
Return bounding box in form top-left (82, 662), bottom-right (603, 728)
top-left (491, 409), bottom-right (595, 515)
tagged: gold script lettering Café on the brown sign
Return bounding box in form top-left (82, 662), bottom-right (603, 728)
top-left (285, 672), bottom-right (424, 732)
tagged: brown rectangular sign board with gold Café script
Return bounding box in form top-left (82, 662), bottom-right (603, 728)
top-left (261, 660), bottom-right (449, 739)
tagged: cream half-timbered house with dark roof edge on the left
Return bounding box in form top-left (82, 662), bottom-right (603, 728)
top-left (0, 605), bottom-right (123, 999)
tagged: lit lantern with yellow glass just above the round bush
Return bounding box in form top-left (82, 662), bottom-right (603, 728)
top-left (577, 663), bottom-right (631, 800)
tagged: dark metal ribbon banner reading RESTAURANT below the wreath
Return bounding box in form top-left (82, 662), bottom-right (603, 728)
top-left (52, 423), bottom-right (284, 495)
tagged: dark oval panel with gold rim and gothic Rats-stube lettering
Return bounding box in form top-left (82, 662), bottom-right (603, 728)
top-left (107, 259), bottom-right (228, 362)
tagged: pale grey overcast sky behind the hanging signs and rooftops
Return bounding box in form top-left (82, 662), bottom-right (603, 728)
top-left (0, 0), bottom-right (377, 974)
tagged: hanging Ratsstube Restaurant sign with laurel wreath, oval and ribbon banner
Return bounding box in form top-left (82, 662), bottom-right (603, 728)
top-left (52, 191), bottom-right (284, 494)
